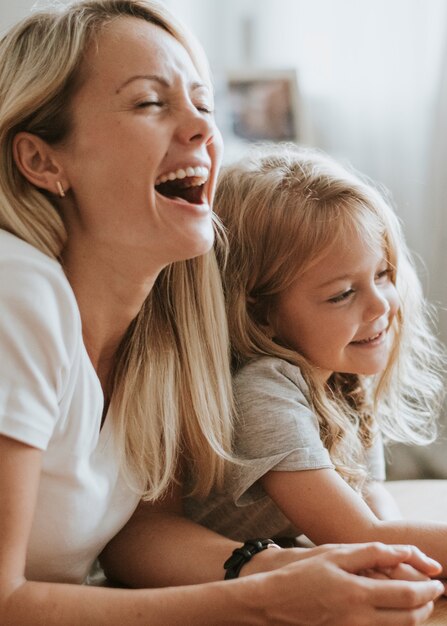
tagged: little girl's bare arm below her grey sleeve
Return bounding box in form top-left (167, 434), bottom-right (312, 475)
top-left (261, 469), bottom-right (447, 570)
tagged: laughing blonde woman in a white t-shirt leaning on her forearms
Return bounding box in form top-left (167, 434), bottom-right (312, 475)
top-left (0, 0), bottom-right (440, 626)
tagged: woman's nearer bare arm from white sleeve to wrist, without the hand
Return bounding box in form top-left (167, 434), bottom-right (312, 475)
top-left (0, 436), bottom-right (252, 626)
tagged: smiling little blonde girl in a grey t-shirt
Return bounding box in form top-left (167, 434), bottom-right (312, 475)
top-left (187, 145), bottom-right (447, 566)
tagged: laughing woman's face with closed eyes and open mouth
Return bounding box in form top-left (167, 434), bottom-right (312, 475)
top-left (58, 17), bottom-right (221, 266)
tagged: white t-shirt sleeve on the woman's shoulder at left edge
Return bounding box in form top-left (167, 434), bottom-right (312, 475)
top-left (0, 253), bottom-right (80, 449)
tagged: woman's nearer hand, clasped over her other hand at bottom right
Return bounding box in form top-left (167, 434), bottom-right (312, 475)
top-left (252, 543), bottom-right (443, 626)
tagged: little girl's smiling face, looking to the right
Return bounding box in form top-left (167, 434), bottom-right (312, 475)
top-left (269, 227), bottom-right (399, 381)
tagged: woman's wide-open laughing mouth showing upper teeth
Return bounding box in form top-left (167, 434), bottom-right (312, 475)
top-left (155, 166), bottom-right (209, 205)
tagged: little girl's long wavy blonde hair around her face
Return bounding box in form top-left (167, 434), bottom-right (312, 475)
top-left (215, 144), bottom-right (444, 489)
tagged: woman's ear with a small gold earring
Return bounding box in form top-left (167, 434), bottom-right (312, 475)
top-left (13, 132), bottom-right (68, 195)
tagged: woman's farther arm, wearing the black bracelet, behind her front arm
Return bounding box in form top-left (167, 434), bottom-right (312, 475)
top-left (100, 478), bottom-right (439, 588)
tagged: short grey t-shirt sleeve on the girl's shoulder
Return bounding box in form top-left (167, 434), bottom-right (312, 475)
top-left (232, 357), bottom-right (334, 506)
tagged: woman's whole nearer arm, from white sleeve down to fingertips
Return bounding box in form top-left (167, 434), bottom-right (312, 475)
top-left (0, 436), bottom-right (441, 626)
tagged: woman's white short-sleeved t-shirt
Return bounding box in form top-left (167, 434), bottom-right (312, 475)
top-left (0, 230), bottom-right (139, 583)
